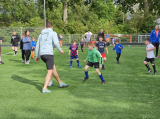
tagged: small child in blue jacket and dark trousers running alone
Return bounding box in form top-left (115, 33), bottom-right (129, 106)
top-left (113, 38), bottom-right (123, 64)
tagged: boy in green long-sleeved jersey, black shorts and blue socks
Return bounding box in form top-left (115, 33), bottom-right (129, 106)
top-left (83, 41), bottom-right (105, 84)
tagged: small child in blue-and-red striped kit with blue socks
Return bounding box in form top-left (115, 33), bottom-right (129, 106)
top-left (69, 40), bottom-right (81, 68)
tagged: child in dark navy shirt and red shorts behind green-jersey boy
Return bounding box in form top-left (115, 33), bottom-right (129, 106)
top-left (96, 36), bottom-right (108, 70)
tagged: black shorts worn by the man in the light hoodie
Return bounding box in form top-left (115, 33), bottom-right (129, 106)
top-left (41, 55), bottom-right (54, 69)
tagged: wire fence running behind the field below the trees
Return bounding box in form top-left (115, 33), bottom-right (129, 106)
top-left (0, 27), bottom-right (150, 44)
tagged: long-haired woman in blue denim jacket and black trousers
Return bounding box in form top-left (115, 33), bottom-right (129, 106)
top-left (22, 30), bottom-right (32, 64)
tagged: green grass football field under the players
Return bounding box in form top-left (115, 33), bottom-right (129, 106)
top-left (0, 46), bottom-right (160, 119)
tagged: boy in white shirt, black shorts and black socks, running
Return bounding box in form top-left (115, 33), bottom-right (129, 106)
top-left (144, 38), bottom-right (156, 75)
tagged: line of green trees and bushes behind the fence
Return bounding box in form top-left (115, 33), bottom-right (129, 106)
top-left (0, 0), bottom-right (160, 34)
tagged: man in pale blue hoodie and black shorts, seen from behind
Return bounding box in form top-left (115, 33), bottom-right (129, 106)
top-left (36, 22), bottom-right (68, 93)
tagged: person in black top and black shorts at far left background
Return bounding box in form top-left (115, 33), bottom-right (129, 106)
top-left (11, 31), bottom-right (20, 56)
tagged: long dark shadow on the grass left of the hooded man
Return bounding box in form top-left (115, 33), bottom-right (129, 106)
top-left (11, 75), bottom-right (43, 91)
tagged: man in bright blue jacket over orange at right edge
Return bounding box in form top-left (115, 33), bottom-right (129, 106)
top-left (150, 25), bottom-right (160, 58)
